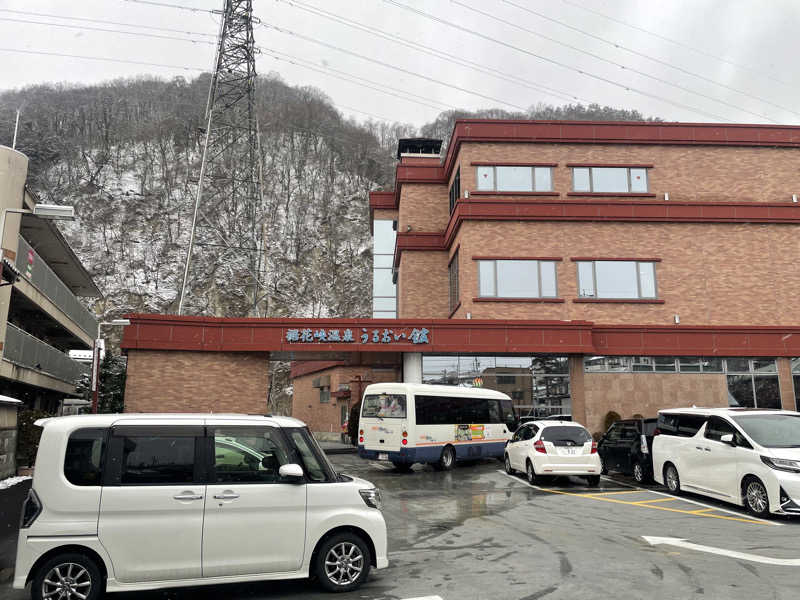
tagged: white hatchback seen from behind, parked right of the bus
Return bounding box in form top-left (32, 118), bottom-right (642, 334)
top-left (505, 421), bottom-right (603, 486)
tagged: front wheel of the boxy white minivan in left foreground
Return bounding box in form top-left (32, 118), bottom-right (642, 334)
top-left (313, 532), bottom-right (372, 592)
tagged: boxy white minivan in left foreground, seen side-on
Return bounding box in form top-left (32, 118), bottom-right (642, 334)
top-left (14, 414), bottom-right (388, 600)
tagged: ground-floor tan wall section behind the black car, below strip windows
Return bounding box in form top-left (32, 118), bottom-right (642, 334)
top-left (573, 373), bottom-right (728, 433)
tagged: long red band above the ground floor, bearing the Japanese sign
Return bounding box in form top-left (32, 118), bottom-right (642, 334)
top-left (121, 314), bottom-right (800, 360)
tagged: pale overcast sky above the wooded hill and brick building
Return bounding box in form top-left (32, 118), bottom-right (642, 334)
top-left (0, 0), bottom-right (800, 125)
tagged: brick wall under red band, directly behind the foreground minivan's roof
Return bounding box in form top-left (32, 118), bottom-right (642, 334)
top-left (125, 350), bottom-right (269, 414)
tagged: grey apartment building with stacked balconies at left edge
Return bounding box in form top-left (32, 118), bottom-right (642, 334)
top-left (0, 146), bottom-right (100, 412)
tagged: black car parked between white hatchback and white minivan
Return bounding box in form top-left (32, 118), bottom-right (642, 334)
top-left (597, 419), bottom-right (658, 483)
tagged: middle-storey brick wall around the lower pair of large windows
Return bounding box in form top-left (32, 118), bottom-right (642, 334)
top-left (450, 221), bottom-right (800, 325)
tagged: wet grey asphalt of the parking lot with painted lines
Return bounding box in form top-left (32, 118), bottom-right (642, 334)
top-left (0, 455), bottom-right (800, 600)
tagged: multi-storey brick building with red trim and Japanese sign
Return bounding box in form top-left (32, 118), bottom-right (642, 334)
top-left (124, 120), bottom-right (800, 432)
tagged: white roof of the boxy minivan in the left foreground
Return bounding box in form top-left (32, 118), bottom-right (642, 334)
top-left (36, 413), bottom-right (305, 430)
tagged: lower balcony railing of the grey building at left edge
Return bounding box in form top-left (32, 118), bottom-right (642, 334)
top-left (3, 323), bottom-right (90, 383)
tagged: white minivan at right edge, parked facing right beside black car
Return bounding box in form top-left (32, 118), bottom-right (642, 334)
top-left (653, 408), bottom-right (800, 516)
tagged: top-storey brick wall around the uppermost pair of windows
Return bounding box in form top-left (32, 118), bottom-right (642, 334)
top-left (456, 143), bottom-right (800, 203)
